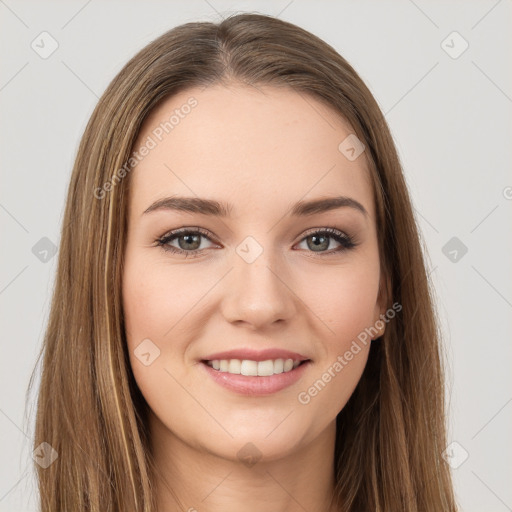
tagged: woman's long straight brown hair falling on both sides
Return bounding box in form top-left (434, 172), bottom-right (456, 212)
top-left (29, 13), bottom-right (456, 512)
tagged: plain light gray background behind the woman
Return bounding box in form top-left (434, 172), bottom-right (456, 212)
top-left (0, 0), bottom-right (512, 512)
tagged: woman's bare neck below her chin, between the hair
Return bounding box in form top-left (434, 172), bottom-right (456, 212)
top-left (150, 413), bottom-right (338, 512)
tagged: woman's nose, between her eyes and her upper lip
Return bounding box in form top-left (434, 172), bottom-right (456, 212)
top-left (221, 246), bottom-right (299, 330)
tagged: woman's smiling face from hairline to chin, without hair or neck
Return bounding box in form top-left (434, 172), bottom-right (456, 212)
top-left (123, 85), bottom-right (383, 460)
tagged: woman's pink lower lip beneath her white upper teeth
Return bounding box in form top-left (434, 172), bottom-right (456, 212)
top-left (201, 361), bottom-right (311, 395)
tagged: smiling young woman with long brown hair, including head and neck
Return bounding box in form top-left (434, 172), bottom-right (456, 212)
top-left (30, 14), bottom-right (456, 512)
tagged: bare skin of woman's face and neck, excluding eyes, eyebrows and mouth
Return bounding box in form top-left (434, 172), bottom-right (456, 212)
top-left (123, 84), bottom-right (385, 512)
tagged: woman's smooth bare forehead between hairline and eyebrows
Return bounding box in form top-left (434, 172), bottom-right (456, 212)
top-left (131, 84), bottom-right (374, 218)
